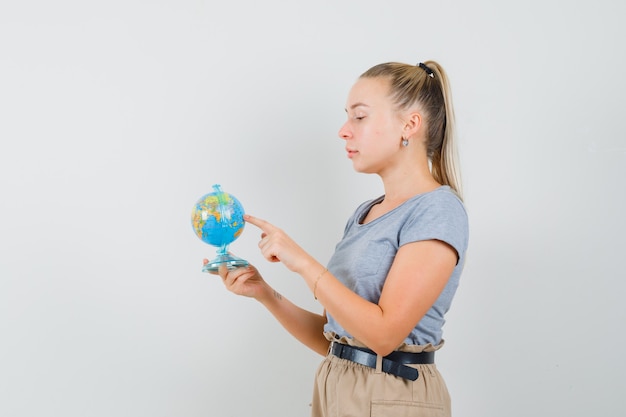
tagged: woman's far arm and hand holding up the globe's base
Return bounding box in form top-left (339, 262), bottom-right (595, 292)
top-left (213, 265), bottom-right (329, 356)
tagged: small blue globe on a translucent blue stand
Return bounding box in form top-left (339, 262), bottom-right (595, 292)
top-left (191, 184), bottom-right (248, 271)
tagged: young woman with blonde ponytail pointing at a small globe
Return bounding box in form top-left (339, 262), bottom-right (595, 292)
top-left (210, 61), bottom-right (468, 417)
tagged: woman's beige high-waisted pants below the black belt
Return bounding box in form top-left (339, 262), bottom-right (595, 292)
top-left (311, 342), bottom-right (451, 417)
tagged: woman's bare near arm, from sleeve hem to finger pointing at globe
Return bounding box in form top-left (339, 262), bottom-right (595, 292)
top-left (246, 216), bottom-right (458, 356)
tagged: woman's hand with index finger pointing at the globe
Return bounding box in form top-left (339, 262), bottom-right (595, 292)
top-left (244, 214), bottom-right (314, 273)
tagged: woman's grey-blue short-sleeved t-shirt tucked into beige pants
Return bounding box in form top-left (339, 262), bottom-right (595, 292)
top-left (324, 186), bottom-right (469, 345)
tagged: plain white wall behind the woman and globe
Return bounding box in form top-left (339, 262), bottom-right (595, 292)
top-left (0, 0), bottom-right (626, 417)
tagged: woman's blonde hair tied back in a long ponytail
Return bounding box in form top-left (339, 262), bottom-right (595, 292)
top-left (361, 61), bottom-right (463, 199)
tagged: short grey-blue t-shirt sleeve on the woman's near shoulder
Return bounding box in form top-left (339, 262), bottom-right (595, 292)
top-left (399, 192), bottom-right (469, 259)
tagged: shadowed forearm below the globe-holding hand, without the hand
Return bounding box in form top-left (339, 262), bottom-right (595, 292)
top-left (259, 290), bottom-right (329, 356)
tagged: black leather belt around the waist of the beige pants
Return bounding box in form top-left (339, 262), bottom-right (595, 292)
top-left (330, 342), bottom-right (435, 381)
